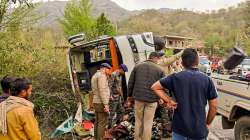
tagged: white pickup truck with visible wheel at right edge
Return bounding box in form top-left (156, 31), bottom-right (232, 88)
top-left (212, 75), bottom-right (250, 140)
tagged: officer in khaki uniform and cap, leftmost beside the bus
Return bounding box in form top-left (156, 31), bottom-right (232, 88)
top-left (91, 63), bottom-right (111, 140)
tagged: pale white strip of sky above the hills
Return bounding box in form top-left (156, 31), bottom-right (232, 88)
top-left (111, 0), bottom-right (245, 11)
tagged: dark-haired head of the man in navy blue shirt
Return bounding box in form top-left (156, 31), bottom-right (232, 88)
top-left (181, 48), bottom-right (199, 68)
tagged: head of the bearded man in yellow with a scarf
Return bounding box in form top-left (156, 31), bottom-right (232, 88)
top-left (11, 78), bottom-right (32, 99)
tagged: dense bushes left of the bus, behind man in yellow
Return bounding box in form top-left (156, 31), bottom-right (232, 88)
top-left (0, 4), bottom-right (76, 139)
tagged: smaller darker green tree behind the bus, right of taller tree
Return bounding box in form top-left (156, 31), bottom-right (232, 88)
top-left (96, 13), bottom-right (115, 36)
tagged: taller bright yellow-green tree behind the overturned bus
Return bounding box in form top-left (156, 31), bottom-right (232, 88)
top-left (60, 0), bottom-right (95, 40)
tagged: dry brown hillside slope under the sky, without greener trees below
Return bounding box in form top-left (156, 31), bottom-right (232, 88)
top-left (119, 7), bottom-right (244, 38)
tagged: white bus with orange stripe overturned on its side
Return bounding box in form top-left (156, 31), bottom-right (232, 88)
top-left (68, 32), bottom-right (165, 99)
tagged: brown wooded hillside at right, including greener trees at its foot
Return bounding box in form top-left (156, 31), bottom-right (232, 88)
top-left (118, 3), bottom-right (250, 55)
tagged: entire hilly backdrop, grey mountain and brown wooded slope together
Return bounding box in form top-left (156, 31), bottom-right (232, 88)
top-left (32, 0), bottom-right (250, 54)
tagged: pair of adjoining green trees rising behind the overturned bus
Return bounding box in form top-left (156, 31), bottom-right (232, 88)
top-left (60, 0), bottom-right (115, 40)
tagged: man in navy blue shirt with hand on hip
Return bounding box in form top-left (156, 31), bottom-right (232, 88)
top-left (152, 48), bottom-right (217, 140)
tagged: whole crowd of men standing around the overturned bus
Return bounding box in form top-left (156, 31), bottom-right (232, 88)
top-left (0, 48), bottom-right (217, 140)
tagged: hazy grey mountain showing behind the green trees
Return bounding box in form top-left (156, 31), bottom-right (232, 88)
top-left (35, 0), bottom-right (143, 26)
